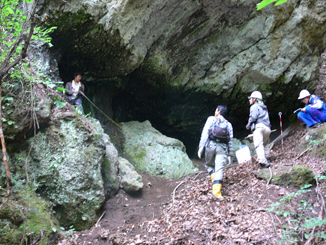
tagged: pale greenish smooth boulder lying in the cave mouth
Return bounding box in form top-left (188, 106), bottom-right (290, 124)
top-left (121, 121), bottom-right (197, 178)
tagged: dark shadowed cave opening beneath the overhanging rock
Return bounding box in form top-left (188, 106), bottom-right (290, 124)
top-left (56, 60), bottom-right (301, 158)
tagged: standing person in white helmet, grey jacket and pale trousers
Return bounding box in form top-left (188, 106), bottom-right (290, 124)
top-left (246, 91), bottom-right (271, 168)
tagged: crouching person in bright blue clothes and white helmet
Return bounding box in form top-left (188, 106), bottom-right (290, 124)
top-left (298, 89), bottom-right (326, 128)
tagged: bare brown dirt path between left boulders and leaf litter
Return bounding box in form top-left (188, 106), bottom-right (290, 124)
top-left (58, 170), bottom-right (196, 245)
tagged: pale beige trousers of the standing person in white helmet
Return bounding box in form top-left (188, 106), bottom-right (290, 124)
top-left (253, 123), bottom-right (271, 165)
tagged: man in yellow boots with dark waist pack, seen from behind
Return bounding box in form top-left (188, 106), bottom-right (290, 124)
top-left (198, 105), bottom-right (233, 199)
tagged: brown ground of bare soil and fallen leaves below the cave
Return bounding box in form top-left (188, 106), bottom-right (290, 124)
top-left (58, 123), bottom-right (326, 245)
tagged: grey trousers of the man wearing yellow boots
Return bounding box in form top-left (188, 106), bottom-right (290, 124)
top-left (205, 141), bottom-right (228, 184)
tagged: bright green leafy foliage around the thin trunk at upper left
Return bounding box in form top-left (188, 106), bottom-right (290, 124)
top-left (0, 0), bottom-right (58, 125)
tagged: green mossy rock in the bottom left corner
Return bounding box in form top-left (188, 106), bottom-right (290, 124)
top-left (0, 189), bottom-right (60, 245)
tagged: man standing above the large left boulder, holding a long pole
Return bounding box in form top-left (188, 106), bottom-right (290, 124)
top-left (66, 72), bottom-right (85, 112)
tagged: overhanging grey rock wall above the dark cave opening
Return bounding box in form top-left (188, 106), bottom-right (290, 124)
top-left (43, 0), bottom-right (326, 91)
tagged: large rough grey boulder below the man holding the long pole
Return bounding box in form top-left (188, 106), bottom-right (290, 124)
top-left (19, 112), bottom-right (105, 230)
